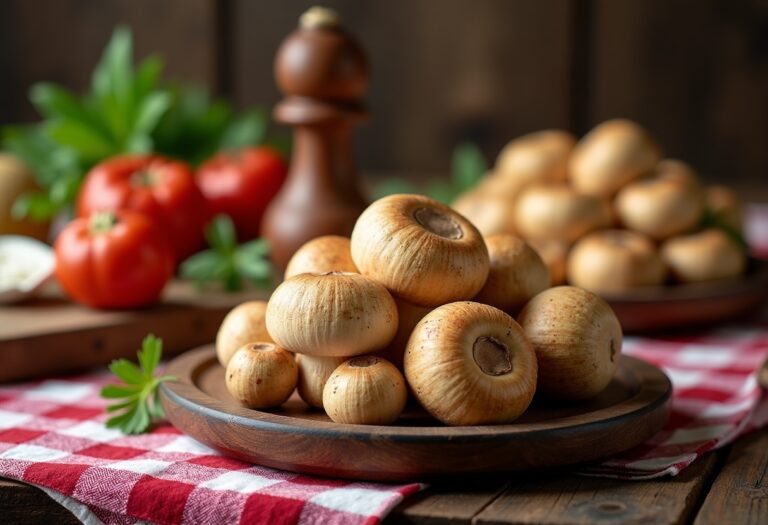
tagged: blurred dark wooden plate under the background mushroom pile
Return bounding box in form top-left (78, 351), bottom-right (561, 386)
top-left (605, 259), bottom-right (768, 333)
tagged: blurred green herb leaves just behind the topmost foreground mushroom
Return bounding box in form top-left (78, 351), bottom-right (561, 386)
top-left (374, 142), bottom-right (488, 204)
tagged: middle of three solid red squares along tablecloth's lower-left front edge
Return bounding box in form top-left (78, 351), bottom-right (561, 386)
top-left (127, 476), bottom-right (195, 523)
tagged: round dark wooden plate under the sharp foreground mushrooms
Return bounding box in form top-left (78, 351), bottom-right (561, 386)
top-left (160, 346), bottom-right (672, 481)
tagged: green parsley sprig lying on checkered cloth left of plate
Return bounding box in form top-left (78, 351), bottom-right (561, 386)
top-left (101, 334), bottom-right (175, 434)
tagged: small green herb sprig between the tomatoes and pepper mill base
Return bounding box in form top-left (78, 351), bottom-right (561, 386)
top-left (181, 215), bottom-right (272, 292)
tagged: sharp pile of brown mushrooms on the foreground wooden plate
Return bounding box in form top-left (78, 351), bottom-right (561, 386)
top-left (216, 192), bottom-right (622, 425)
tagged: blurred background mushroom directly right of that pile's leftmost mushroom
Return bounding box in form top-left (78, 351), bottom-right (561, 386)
top-left (514, 184), bottom-right (611, 243)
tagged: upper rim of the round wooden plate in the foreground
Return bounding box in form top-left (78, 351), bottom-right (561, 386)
top-left (160, 345), bottom-right (672, 443)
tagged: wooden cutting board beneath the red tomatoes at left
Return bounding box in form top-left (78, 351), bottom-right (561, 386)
top-left (0, 282), bottom-right (268, 382)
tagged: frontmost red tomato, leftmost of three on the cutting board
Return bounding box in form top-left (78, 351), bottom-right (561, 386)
top-left (54, 211), bottom-right (174, 308)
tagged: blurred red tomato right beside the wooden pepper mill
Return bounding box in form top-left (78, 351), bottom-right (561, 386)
top-left (197, 146), bottom-right (288, 242)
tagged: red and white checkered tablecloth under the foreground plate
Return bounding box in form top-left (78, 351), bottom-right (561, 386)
top-left (0, 207), bottom-right (768, 524)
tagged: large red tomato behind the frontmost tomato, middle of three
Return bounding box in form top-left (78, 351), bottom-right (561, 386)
top-left (77, 155), bottom-right (209, 261)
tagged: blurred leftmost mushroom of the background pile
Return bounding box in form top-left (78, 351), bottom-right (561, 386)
top-left (451, 188), bottom-right (515, 237)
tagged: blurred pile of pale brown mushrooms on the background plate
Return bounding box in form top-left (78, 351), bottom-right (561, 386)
top-left (453, 120), bottom-right (747, 295)
